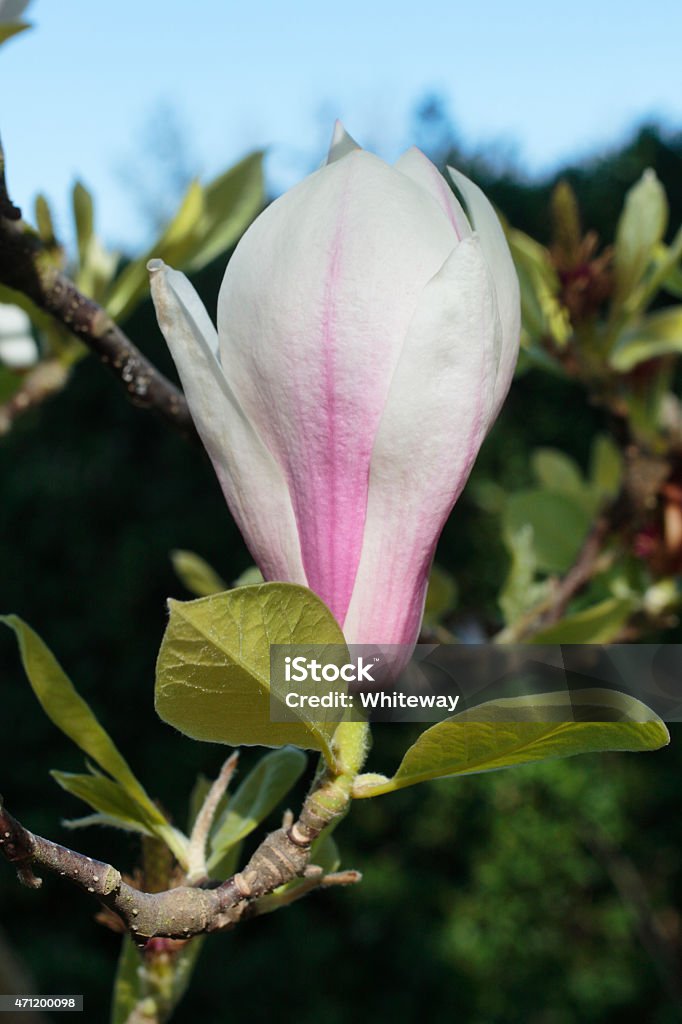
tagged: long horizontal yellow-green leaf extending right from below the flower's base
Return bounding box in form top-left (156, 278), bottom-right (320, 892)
top-left (353, 689), bottom-right (670, 799)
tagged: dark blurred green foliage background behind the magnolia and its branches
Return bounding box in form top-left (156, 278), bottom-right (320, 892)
top-left (0, 121), bottom-right (682, 1024)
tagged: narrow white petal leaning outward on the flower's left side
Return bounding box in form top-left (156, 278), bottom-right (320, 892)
top-left (148, 260), bottom-right (306, 584)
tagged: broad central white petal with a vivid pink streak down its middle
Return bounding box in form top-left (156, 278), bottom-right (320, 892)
top-left (218, 150), bottom-right (454, 624)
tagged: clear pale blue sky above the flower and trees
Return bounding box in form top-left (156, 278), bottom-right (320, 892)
top-left (0, 0), bottom-right (682, 246)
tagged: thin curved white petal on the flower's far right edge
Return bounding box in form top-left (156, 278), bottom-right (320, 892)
top-left (447, 167), bottom-right (521, 422)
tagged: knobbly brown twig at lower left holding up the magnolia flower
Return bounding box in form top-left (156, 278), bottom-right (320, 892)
top-left (0, 775), bottom-right (360, 945)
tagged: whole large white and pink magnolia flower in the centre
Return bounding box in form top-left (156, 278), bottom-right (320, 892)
top-left (150, 125), bottom-right (519, 644)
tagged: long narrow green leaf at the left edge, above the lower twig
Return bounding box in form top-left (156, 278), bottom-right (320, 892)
top-left (0, 615), bottom-right (175, 830)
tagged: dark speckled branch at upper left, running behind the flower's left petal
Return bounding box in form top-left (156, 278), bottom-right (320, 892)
top-left (0, 139), bottom-right (196, 436)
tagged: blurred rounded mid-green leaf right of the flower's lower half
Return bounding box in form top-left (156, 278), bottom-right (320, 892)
top-left (503, 488), bottom-right (592, 572)
